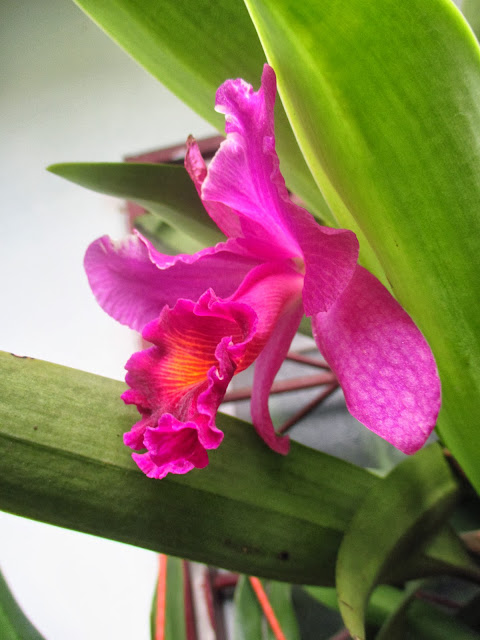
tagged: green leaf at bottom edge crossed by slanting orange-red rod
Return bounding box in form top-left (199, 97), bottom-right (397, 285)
top-left (234, 576), bottom-right (300, 640)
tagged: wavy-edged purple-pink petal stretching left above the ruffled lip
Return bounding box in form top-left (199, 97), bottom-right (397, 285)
top-left (85, 232), bottom-right (258, 331)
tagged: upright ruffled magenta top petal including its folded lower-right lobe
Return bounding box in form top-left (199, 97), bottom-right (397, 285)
top-left (201, 65), bottom-right (358, 315)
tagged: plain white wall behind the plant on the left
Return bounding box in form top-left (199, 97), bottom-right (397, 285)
top-left (0, 0), bottom-right (214, 640)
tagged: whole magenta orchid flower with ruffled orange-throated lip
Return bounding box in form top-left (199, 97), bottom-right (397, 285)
top-left (85, 65), bottom-right (440, 478)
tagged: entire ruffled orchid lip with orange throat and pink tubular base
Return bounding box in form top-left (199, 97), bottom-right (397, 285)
top-left (122, 261), bottom-right (302, 477)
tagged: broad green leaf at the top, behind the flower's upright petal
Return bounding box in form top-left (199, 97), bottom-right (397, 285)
top-left (70, 0), bottom-right (332, 228)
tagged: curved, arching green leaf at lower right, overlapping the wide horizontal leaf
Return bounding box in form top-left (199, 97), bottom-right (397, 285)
top-left (337, 444), bottom-right (459, 640)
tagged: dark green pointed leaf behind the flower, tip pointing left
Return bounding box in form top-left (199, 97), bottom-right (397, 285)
top-left (48, 162), bottom-right (220, 248)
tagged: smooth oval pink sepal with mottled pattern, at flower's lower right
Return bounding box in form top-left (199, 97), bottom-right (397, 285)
top-left (312, 266), bottom-right (440, 454)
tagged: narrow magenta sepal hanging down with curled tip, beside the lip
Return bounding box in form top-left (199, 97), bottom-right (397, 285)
top-left (251, 302), bottom-right (303, 455)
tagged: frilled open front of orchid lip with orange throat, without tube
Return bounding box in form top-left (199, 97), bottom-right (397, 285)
top-left (122, 291), bottom-right (257, 464)
